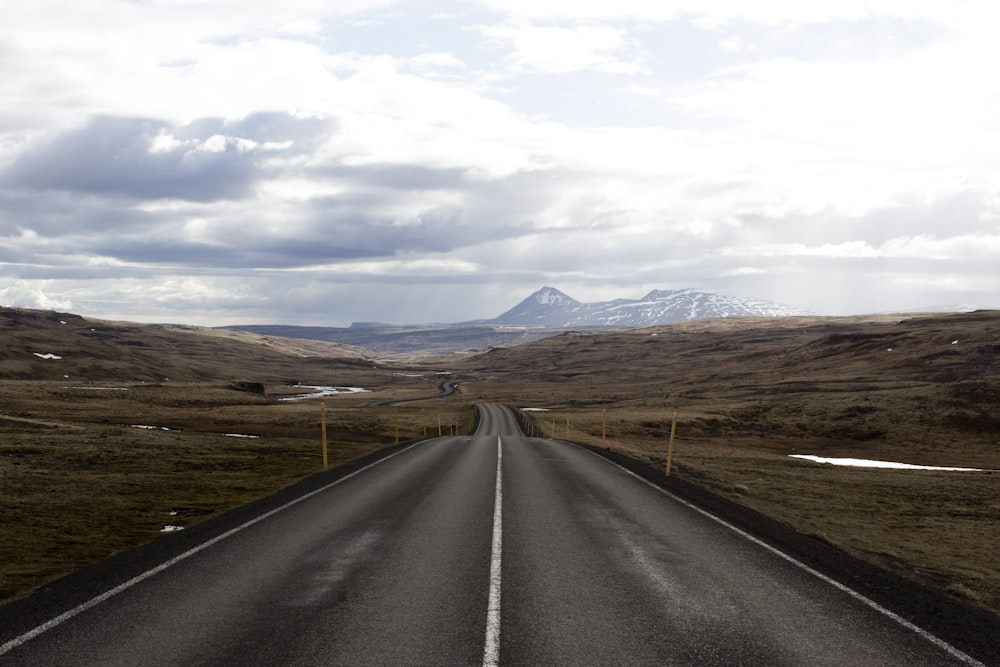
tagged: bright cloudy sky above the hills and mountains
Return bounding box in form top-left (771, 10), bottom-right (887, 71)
top-left (0, 0), bottom-right (1000, 326)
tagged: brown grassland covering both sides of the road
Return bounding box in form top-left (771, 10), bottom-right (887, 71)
top-left (0, 308), bottom-right (1000, 613)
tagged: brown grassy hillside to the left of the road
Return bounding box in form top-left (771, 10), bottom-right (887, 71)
top-left (0, 308), bottom-right (469, 602)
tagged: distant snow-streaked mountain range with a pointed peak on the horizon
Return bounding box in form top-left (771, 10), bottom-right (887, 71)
top-left (491, 287), bottom-right (810, 328)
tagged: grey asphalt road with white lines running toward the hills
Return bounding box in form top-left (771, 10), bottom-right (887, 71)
top-left (0, 406), bottom-right (978, 666)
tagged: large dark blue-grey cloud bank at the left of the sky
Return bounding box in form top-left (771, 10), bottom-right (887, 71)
top-left (0, 125), bottom-right (580, 274)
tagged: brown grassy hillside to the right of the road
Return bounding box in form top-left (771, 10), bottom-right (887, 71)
top-left (458, 312), bottom-right (1000, 611)
